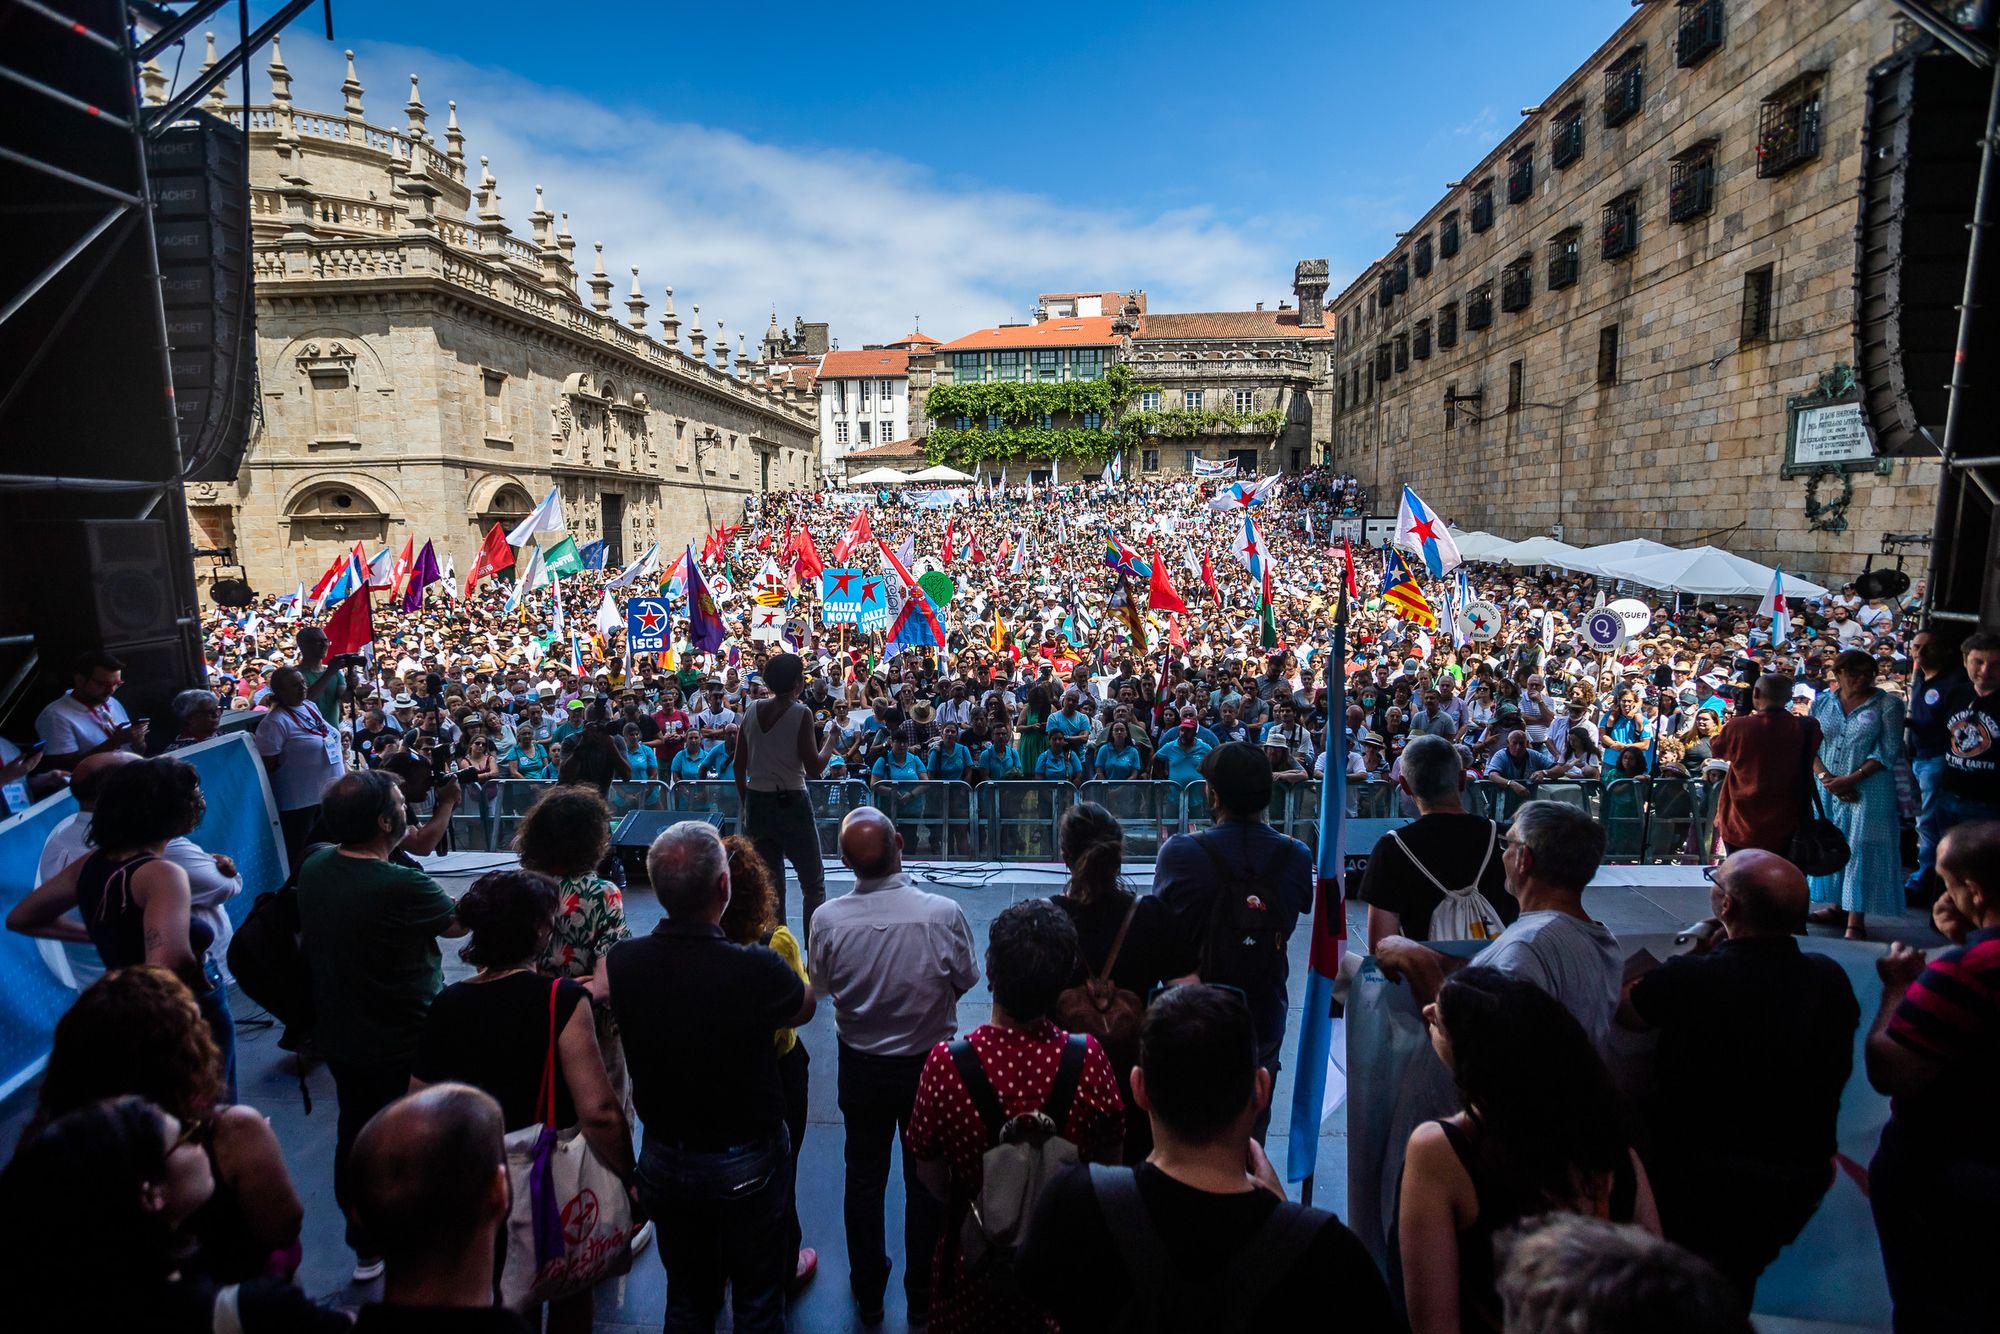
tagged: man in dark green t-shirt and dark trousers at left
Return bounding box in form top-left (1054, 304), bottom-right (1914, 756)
top-left (298, 770), bottom-right (466, 1282)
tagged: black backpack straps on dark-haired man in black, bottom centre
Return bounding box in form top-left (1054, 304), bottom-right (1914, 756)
top-left (1090, 1164), bottom-right (1332, 1334)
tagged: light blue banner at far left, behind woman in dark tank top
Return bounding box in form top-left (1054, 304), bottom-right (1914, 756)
top-left (0, 732), bottom-right (286, 1098)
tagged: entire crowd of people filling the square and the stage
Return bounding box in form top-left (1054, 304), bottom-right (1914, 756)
top-left (0, 462), bottom-right (2000, 1334)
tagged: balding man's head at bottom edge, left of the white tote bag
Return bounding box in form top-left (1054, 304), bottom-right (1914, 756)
top-left (352, 1084), bottom-right (528, 1334)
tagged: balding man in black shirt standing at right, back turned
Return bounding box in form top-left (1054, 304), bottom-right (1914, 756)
top-left (1618, 848), bottom-right (1860, 1310)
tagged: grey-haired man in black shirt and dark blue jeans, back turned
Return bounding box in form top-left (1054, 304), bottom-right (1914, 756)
top-left (606, 820), bottom-right (816, 1334)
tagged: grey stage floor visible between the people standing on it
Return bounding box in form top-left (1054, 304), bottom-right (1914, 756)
top-left (0, 854), bottom-right (1936, 1334)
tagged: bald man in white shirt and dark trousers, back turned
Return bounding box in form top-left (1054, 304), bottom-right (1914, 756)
top-left (810, 806), bottom-right (980, 1322)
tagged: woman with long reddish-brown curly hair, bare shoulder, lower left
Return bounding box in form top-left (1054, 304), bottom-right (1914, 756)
top-left (22, 966), bottom-right (306, 1284)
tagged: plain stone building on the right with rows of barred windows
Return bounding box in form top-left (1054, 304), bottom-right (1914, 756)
top-left (1332, 0), bottom-right (1936, 578)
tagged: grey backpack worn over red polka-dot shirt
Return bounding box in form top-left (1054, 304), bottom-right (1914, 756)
top-left (946, 1034), bottom-right (1090, 1288)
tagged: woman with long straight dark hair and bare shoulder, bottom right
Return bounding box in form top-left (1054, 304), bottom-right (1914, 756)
top-left (1390, 968), bottom-right (1660, 1334)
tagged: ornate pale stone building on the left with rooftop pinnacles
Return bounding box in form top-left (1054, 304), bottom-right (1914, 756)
top-left (174, 42), bottom-right (824, 590)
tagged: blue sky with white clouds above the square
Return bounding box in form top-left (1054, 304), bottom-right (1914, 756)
top-left (207, 0), bottom-right (1632, 346)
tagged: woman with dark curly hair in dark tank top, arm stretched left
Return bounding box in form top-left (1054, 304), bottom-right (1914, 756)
top-left (6, 756), bottom-right (236, 1098)
